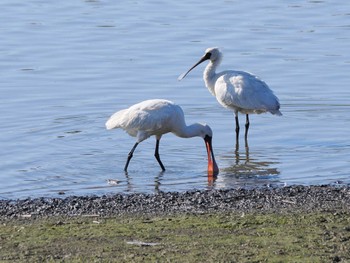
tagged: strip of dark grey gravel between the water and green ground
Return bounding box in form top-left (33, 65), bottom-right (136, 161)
top-left (0, 185), bottom-right (350, 219)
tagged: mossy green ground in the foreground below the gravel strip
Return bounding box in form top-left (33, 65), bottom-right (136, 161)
top-left (0, 213), bottom-right (350, 262)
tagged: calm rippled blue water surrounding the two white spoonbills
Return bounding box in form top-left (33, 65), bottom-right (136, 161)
top-left (0, 0), bottom-right (350, 198)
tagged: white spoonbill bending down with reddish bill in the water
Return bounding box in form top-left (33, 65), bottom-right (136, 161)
top-left (106, 99), bottom-right (219, 176)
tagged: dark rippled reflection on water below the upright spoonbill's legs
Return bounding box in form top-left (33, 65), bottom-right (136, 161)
top-left (216, 143), bottom-right (282, 188)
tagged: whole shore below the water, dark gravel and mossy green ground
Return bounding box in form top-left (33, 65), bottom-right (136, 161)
top-left (0, 185), bottom-right (350, 263)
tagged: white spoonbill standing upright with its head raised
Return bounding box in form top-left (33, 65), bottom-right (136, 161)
top-left (178, 47), bottom-right (282, 144)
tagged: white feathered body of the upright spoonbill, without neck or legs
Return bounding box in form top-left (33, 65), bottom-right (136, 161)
top-left (215, 71), bottom-right (281, 115)
